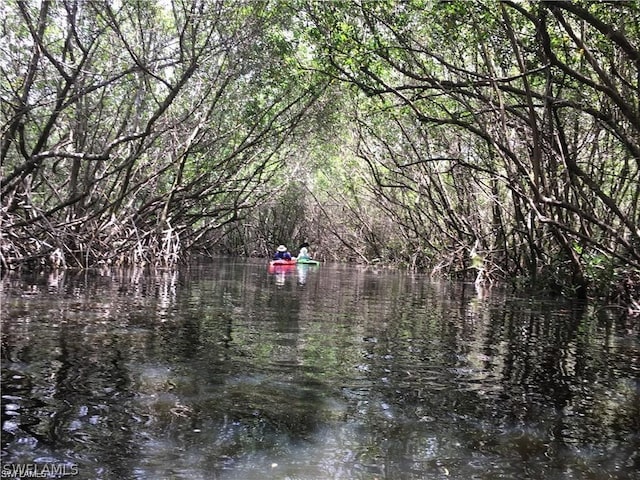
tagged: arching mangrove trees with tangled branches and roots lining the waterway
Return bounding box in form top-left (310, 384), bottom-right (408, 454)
top-left (0, 0), bottom-right (640, 316)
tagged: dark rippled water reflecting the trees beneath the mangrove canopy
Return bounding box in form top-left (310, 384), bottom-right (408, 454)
top-left (2, 261), bottom-right (640, 480)
